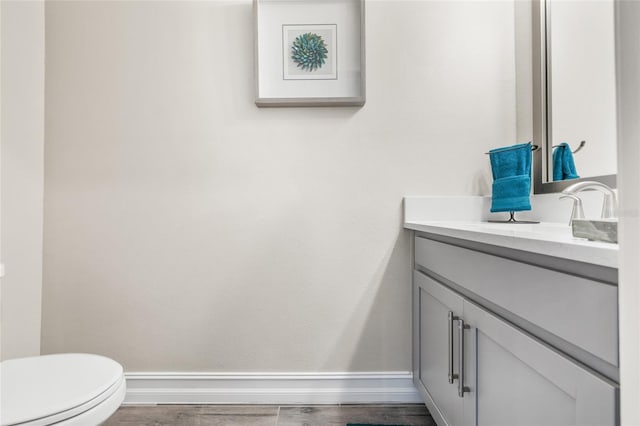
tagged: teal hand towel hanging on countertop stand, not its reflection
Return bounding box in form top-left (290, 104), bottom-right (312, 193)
top-left (489, 143), bottom-right (531, 212)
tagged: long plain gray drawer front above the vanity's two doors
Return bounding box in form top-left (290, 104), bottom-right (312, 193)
top-left (415, 237), bottom-right (618, 366)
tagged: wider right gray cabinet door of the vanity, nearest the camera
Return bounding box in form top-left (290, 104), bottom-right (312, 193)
top-left (463, 300), bottom-right (618, 426)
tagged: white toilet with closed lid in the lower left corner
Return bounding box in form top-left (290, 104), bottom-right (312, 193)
top-left (0, 354), bottom-right (127, 426)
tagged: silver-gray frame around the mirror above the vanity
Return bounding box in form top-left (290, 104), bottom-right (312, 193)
top-left (531, 0), bottom-right (617, 194)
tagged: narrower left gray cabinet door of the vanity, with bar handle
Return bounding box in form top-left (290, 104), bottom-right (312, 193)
top-left (413, 271), bottom-right (463, 426)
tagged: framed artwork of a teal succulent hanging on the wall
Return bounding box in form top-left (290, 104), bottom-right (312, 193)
top-left (254, 0), bottom-right (365, 106)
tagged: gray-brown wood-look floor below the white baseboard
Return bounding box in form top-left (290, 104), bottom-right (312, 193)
top-left (104, 404), bottom-right (436, 426)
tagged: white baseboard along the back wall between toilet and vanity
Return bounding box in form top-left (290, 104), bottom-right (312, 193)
top-left (124, 372), bottom-right (422, 405)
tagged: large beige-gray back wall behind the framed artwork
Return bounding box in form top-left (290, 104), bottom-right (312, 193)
top-left (42, 0), bottom-right (516, 372)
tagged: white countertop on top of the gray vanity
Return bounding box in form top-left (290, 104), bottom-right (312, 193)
top-left (404, 220), bottom-right (618, 268)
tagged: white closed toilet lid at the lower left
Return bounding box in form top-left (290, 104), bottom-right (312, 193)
top-left (0, 354), bottom-right (123, 425)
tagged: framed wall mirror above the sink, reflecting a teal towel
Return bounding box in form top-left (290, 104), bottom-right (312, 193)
top-left (532, 0), bottom-right (617, 193)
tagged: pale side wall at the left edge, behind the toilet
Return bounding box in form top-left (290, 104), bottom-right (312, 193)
top-left (0, 1), bottom-right (45, 359)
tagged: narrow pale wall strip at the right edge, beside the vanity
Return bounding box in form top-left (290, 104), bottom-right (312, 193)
top-left (616, 0), bottom-right (640, 425)
